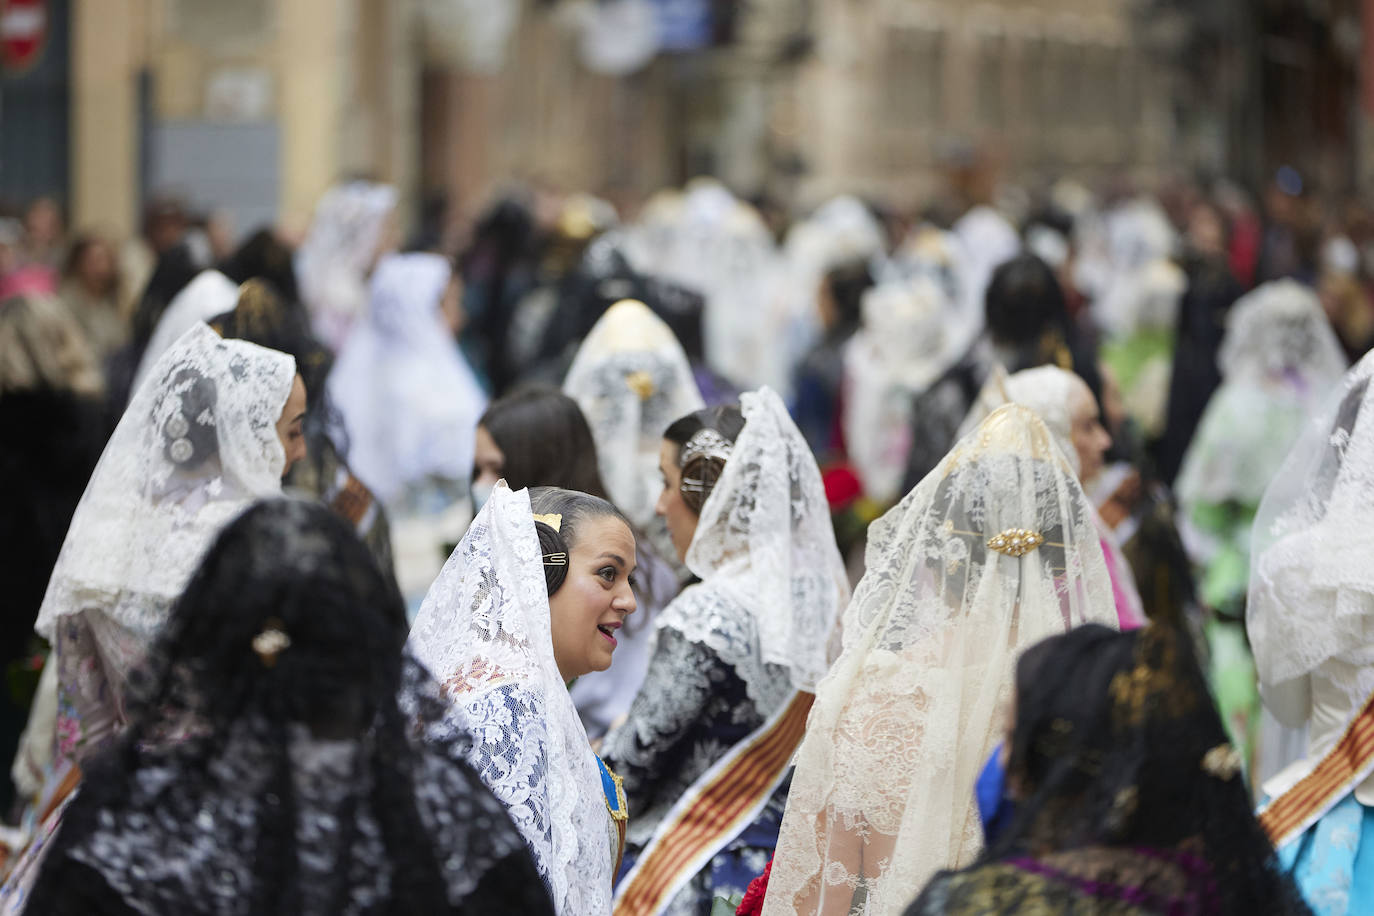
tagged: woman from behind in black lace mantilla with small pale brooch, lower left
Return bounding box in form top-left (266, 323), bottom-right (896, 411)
top-left (29, 500), bottom-right (552, 916)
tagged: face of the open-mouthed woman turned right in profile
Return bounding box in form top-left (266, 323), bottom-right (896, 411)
top-left (548, 515), bottom-right (635, 681)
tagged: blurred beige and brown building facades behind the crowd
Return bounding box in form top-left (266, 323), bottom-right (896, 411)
top-left (8, 0), bottom-right (1374, 240)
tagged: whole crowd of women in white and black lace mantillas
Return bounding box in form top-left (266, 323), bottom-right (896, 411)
top-left (0, 170), bottom-right (1374, 916)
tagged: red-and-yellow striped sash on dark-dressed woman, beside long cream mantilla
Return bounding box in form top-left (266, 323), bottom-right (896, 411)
top-left (614, 692), bottom-right (816, 916)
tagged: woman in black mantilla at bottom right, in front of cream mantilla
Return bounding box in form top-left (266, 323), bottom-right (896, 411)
top-left (907, 623), bottom-right (1308, 916)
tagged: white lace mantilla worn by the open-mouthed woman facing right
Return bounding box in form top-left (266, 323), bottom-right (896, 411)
top-left (407, 485), bottom-right (613, 916)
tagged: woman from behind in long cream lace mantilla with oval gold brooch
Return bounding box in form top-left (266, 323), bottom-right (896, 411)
top-left (764, 405), bottom-right (1117, 916)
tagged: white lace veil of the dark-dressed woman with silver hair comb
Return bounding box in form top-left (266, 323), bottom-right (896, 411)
top-left (658, 387), bottom-right (849, 713)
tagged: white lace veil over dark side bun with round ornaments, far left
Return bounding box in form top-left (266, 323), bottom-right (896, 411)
top-left (34, 323), bottom-right (295, 640)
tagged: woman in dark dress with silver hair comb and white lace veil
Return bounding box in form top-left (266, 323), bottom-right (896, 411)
top-left (603, 389), bottom-right (849, 913)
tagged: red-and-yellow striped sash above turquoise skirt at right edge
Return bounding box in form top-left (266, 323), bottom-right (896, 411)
top-left (1260, 683), bottom-right (1374, 849)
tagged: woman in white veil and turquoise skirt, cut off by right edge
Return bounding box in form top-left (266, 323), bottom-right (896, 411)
top-left (1246, 347), bottom-right (1374, 913)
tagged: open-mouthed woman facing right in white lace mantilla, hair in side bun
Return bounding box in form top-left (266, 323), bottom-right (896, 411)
top-left (408, 485), bottom-right (635, 916)
